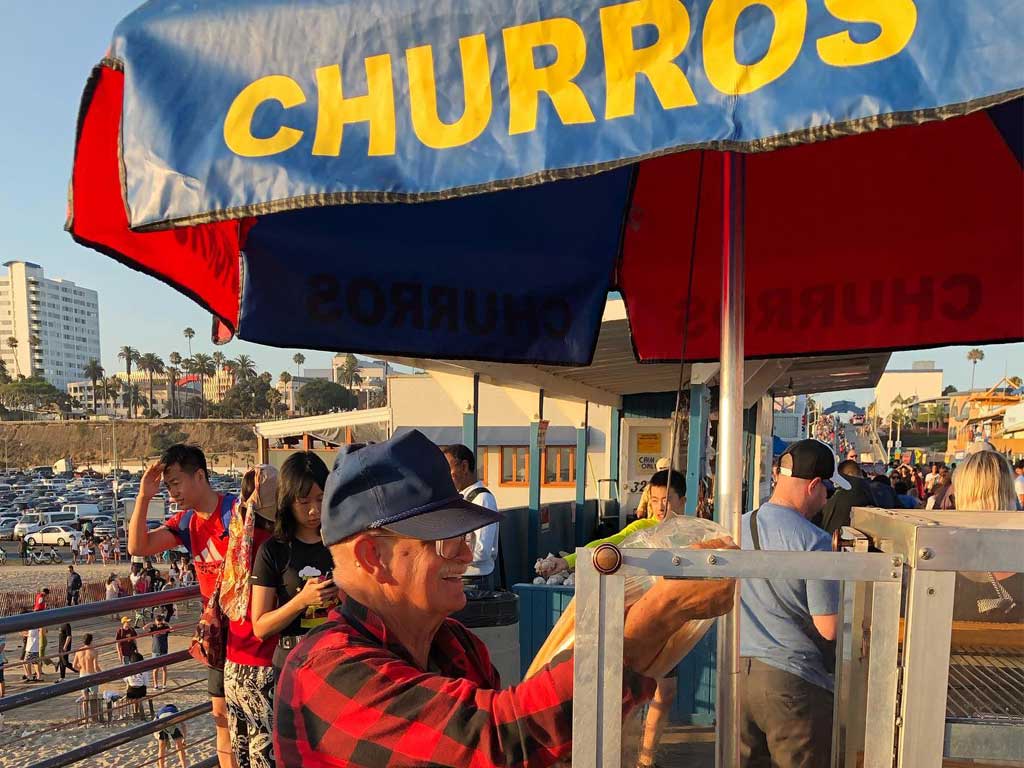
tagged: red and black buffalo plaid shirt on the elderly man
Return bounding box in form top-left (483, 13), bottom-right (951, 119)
top-left (273, 598), bottom-right (655, 768)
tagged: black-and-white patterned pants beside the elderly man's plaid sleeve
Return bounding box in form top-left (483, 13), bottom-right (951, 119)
top-left (224, 662), bottom-right (274, 768)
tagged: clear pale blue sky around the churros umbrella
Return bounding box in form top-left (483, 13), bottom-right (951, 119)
top-left (0, 0), bottom-right (1024, 403)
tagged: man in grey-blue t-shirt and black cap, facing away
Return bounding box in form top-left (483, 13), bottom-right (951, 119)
top-left (739, 440), bottom-right (850, 768)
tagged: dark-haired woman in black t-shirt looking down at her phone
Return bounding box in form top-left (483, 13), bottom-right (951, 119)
top-left (251, 451), bottom-right (338, 670)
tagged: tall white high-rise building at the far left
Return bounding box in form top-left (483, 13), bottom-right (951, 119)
top-left (0, 261), bottom-right (99, 390)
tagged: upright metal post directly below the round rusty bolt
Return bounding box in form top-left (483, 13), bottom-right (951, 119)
top-left (572, 549), bottom-right (626, 768)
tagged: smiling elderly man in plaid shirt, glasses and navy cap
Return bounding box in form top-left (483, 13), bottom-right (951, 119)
top-left (274, 430), bottom-right (734, 768)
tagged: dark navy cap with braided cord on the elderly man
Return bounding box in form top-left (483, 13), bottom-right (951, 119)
top-left (321, 429), bottom-right (503, 546)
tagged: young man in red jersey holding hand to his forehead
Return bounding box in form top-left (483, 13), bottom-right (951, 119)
top-left (128, 443), bottom-right (236, 768)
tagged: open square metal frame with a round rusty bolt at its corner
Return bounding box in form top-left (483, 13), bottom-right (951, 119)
top-left (572, 545), bottom-right (905, 768)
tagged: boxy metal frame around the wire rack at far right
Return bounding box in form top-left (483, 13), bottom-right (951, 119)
top-left (846, 507), bottom-right (1024, 768)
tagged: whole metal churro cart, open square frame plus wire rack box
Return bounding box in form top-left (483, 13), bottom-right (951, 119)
top-left (572, 508), bottom-right (1024, 768)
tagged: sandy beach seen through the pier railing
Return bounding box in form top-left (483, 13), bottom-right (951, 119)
top-left (0, 562), bottom-right (213, 768)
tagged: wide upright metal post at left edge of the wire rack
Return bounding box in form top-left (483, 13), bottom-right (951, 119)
top-left (892, 568), bottom-right (956, 768)
